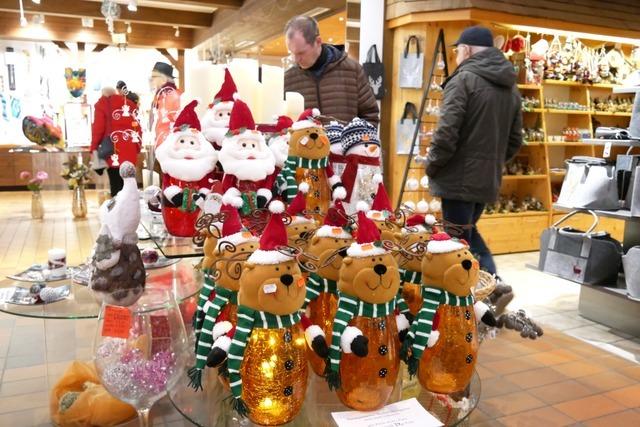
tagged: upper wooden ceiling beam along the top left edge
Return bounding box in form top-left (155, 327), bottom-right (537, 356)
top-left (0, 0), bottom-right (213, 28)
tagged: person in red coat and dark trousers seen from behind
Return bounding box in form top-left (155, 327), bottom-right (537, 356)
top-left (91, 82), bottom-right (142, 197)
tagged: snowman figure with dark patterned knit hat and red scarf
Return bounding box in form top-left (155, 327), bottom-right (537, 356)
top-left (341, 117), bottom-right (382, 214)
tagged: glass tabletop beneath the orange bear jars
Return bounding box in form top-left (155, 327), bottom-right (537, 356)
top-left (169, 364), bottom-right (481, 427)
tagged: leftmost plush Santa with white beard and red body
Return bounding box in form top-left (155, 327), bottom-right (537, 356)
top-left (155, 101), bottom-right (217, 237)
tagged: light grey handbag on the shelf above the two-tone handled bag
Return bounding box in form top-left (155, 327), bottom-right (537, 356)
top-left (558, 156), bottom-right (620, 210)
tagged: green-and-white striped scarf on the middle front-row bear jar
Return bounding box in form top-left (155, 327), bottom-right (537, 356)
top-left (328, 291), bottom-right (396, 373)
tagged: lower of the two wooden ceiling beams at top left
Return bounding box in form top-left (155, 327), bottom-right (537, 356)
top-left (0, 12), bottom-right (194, 49)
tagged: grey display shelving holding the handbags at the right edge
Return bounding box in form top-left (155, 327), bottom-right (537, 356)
top-left (553, 204), bottom-right (640, 337)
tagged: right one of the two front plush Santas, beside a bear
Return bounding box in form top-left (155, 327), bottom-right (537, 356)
top-left (218, 99), bottom-right (275, 217)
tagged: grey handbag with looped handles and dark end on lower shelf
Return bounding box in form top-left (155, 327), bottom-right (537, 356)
top-left (538, 211), bottom-right (623, 287)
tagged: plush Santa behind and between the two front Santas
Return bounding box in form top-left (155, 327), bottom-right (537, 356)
top-left (202, 68), bottom-right (238, 150)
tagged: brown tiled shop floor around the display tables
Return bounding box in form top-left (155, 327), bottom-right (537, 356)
top-left (0, 192), bottom-right (640, 427)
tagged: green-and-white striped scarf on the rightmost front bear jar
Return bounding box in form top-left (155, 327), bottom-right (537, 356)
top-left (407, 286), bottom-right (473, 360)
